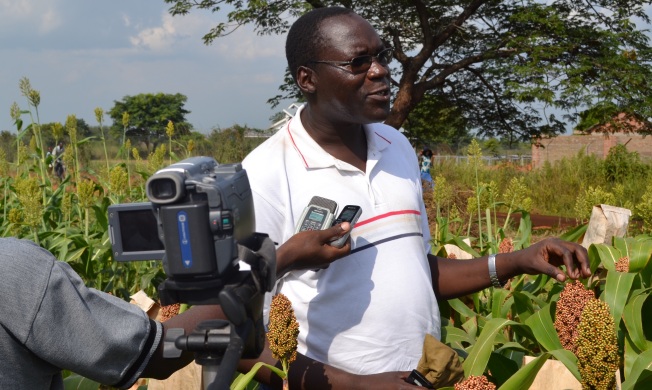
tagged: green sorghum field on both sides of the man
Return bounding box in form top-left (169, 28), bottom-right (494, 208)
top-left (0, 100), bottom-right (652, 389)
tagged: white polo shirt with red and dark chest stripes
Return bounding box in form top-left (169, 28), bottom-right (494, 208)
top-left (243, 109), bottom-right (440, 374)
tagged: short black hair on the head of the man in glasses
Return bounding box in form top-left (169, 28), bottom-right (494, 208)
top-left (285, 7), bottom-right (355, 82)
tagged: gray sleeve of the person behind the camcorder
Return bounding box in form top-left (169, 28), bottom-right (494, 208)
top-left (0, 241), bottom-right (163, 388)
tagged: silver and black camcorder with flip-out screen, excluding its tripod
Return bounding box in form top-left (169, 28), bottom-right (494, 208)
top-left (108, 157), bottom-right (255, 304)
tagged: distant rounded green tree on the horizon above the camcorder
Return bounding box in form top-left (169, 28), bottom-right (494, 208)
top-left (108, 93), bottom-right (192, 151)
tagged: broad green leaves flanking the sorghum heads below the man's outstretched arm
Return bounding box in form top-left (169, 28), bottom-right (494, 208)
top-left (440, 236), bottom-right (652, 389)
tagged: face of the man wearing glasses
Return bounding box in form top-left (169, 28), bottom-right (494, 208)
top-left (311, 15), bottom-right (390, 124)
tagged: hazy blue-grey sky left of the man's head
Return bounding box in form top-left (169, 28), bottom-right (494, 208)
top-left (0, 0), bottom-right (292, 133)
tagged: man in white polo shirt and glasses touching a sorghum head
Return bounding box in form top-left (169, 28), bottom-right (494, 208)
top-left (241, 7), bottom-right (590, 389)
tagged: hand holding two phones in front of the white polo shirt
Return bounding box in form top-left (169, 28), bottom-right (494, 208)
top-left (276, 222), bottom-right (351, 277)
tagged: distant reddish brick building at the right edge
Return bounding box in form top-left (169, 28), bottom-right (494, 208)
top-left (532, 113), bottom-right (652, 168)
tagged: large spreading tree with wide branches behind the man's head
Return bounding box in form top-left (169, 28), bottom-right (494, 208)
top-left (165, 0), bottom-right (652, 140)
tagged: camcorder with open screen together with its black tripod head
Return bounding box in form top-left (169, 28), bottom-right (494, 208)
top-left (108, 157), bottom-right (276, 389)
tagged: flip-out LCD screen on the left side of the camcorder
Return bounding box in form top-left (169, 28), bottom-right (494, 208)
top-left (109, 203), bottom-right (165, 261)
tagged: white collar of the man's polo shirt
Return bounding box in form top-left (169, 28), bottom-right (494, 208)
top-left (283, 106), bottom-right (391, 170)
